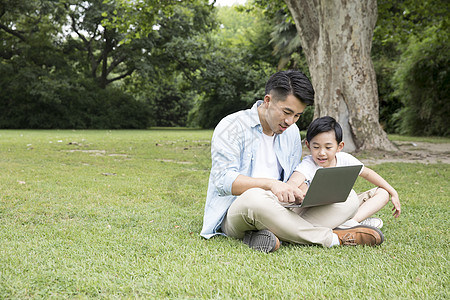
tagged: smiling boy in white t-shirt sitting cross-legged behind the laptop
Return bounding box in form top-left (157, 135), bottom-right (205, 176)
top-left (288, 116), bottom-right (401, 228)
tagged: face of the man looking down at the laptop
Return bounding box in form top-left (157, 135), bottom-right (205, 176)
top-left (261, 94), bottom-right (306, 134)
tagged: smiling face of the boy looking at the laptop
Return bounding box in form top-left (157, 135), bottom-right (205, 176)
top-left (306, 131), bottom-right (344, 168)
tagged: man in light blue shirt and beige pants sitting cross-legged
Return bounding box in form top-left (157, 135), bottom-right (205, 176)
top-left (201, 70), bottom-right (383, 253)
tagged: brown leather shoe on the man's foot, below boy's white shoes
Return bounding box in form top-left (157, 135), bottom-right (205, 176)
top-left (333, 225), bottom-right (384, 246)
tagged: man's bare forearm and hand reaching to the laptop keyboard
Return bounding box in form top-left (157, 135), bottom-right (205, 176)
top-left (231, 175), bottom-right (304, 203)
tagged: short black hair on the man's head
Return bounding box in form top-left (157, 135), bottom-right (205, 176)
top-left (266, 70), bottom-right (314, 105)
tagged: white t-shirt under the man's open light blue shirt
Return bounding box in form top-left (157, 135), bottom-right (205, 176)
top-left (252, 133), bottom-right (283, 180)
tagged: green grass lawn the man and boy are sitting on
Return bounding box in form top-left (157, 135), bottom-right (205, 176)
top-left (0, 130), bottom-right (450, 299)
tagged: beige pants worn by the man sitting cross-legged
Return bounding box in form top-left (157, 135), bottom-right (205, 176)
top-left (222, 188), bottom-right (359, 247)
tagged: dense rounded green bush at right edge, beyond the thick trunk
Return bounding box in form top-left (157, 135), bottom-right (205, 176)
top-left (394, 27), bottom-right (450, 136)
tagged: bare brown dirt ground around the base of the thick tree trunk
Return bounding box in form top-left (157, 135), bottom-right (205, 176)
top-left (303, 142), bottom-right (450, 165)
